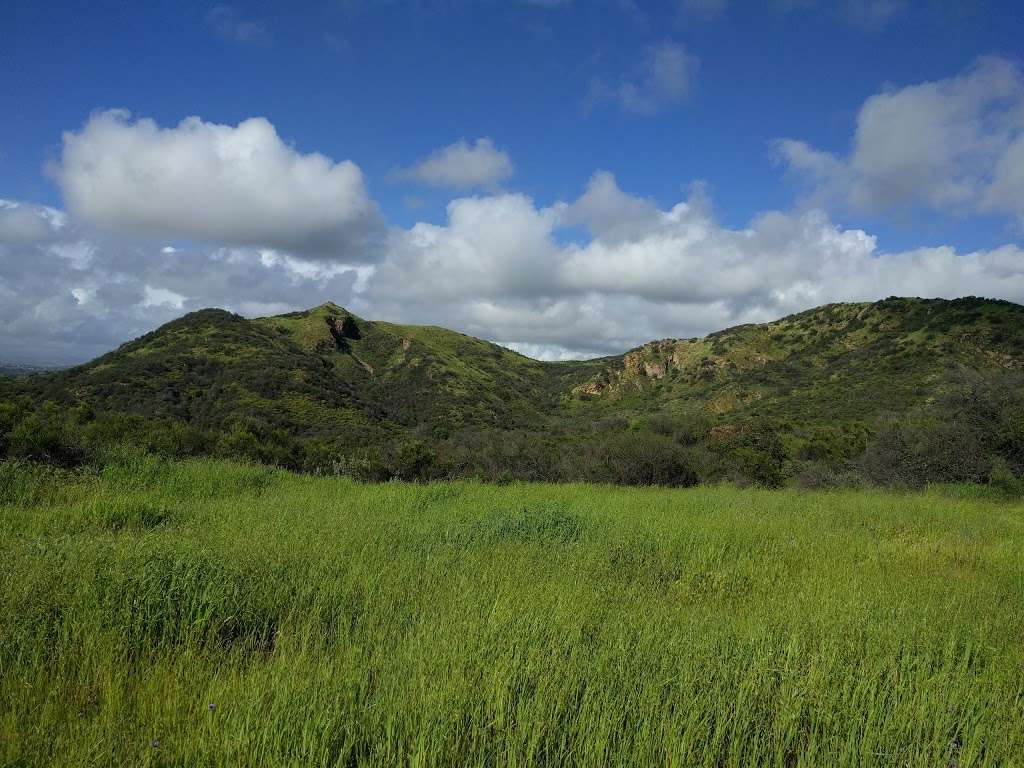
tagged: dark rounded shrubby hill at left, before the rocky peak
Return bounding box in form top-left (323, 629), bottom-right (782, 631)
top-left (15, 309), bottom-right (398, 456)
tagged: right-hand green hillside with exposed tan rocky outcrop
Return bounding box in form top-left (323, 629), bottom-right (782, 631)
top-left (572, 298), bottom-right (1024, 422)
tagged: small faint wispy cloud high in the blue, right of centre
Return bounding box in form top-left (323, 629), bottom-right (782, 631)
top-left (587, 41), bottom-right (700, 115)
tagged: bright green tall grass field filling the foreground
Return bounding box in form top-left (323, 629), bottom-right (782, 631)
top-left (0, 459), bottom-right (1024, 767)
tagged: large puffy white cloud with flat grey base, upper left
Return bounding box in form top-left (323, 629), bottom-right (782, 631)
top-left (52, 111), bottom-right (380, 262)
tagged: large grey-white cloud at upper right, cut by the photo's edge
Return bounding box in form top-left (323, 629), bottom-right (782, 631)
top-left (775, 57), bottom-right (1024, 223)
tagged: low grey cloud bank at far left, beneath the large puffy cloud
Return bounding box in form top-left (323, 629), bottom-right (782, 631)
top-left (0, 201), bottom-right (364, 365)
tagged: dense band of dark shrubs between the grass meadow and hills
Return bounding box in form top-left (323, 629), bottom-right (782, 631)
top-left (0, 371), bottom-right (1024, 493)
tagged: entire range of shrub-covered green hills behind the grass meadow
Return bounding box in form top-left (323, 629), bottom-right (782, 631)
top-left (6, 298), bottom-right (1024, 484)
